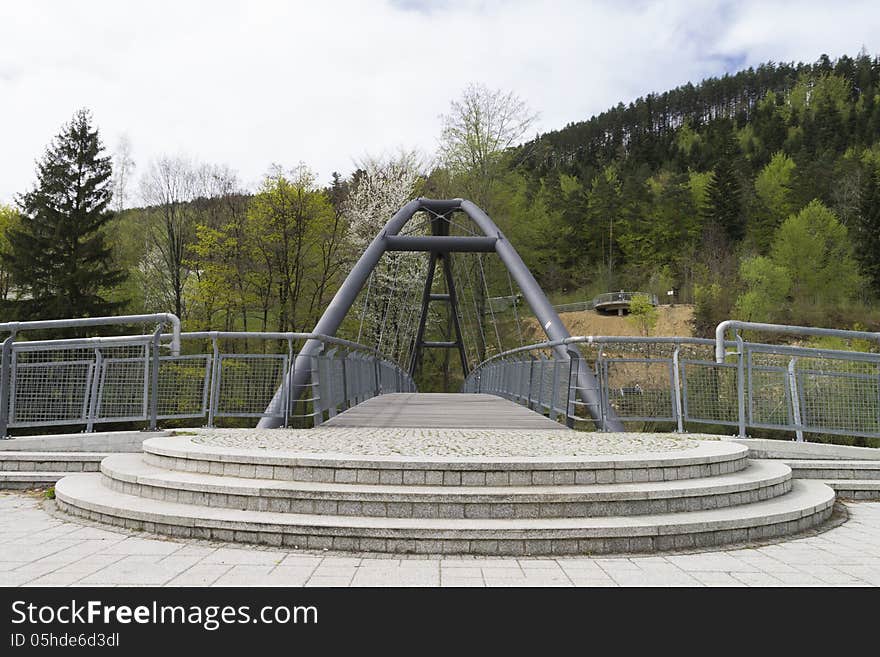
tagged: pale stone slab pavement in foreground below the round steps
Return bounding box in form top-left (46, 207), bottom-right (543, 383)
top-left (0, 493), bottom-right (880, 586)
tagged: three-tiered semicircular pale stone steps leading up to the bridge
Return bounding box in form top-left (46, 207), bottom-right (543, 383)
top-left (55, 436), bottom-right (835, 555)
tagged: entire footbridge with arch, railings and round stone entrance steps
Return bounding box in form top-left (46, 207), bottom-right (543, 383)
top-left (0, 199), bottom-right (880, 555)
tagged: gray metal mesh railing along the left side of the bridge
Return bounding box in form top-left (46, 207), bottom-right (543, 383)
top-left (0, 329), bottom-right (415, 437)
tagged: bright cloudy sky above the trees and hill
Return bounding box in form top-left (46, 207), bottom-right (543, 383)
top-left (0, 0), bottom-right (880, 204)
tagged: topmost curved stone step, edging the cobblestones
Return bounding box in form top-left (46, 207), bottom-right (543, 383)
top-left (144, 437), bottom-right (749, 486)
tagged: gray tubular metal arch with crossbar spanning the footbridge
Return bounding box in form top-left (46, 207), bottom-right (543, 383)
top-left (258, 198), bottom-right (623, 431)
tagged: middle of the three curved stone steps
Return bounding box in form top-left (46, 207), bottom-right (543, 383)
top-left (101, 454), bottom-right (791, 518)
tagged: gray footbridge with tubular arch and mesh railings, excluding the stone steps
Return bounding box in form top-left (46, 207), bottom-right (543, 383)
top-left (0, 199), bottom-right (880, 439)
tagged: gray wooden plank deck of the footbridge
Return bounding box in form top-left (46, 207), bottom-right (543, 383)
top-left (324, 393), bottom-right (566, 429)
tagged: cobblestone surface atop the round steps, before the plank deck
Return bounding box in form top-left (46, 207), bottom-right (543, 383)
top-left (191, 427), bottom-right (718, 458)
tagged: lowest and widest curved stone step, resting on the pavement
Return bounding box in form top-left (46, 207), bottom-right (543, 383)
top-left (55, 474), bottom-right (834, 555)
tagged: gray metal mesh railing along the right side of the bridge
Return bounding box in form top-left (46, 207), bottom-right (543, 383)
top-left (463, 336), bottom-right (880, 440)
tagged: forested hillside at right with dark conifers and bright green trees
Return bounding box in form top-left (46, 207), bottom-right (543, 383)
top-left (502, 51), bottom-right (880, 332)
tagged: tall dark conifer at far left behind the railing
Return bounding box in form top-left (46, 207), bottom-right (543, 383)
top-left (3, 109), bottom-right (125, 319)
